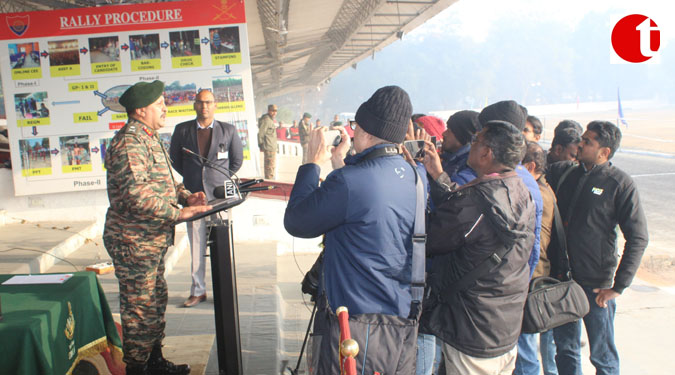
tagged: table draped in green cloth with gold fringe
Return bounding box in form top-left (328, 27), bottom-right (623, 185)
top-left (0, 271), bottom-right (122, 375)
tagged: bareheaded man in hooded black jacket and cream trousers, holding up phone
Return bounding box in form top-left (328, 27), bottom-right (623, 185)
top-left (420, 121), bottom-right (535, 374)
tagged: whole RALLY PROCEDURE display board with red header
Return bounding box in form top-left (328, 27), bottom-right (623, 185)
top-left (0, 0), bottom-right (259, 195)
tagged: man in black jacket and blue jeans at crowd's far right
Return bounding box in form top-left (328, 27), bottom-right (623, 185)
top-left (547, 121), bottom-right (648, 375)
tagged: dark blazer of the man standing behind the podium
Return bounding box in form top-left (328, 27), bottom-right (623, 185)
top-left (169, 120), bottom-right (244, 200)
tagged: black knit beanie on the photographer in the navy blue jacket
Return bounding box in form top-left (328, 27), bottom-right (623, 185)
top-left (354, 86), bottom-right (412, 143)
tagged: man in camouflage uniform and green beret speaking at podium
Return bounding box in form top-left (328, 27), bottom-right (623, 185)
top-left (103, 81), bottom-right (210, 375)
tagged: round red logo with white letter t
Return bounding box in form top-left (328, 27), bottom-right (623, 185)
top-left (612, 14), bottom-right (661, 63)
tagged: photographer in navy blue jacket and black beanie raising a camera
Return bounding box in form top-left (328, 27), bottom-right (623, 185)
top-left (284, 86), bottom-right (417, 375)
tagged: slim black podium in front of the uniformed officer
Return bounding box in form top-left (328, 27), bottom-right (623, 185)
top-left (186, 195), bottom-right (246, 375)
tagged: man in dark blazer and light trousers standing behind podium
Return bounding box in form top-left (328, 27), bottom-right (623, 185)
top-left (170, 90), bottom-right (244, 307)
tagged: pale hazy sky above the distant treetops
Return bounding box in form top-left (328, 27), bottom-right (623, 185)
top-left (407, 0), bottom-right (675, 46)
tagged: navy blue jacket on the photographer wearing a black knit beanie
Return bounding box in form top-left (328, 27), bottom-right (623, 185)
top-left (284, 145), bottom-right (416, 318)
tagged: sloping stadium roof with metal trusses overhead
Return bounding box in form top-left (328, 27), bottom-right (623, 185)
top-left (0, 0), bottom-right (458, 100)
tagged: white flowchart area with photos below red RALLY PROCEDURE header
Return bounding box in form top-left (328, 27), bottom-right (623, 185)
top-left (0, 0), bottom-right (255, 194)
